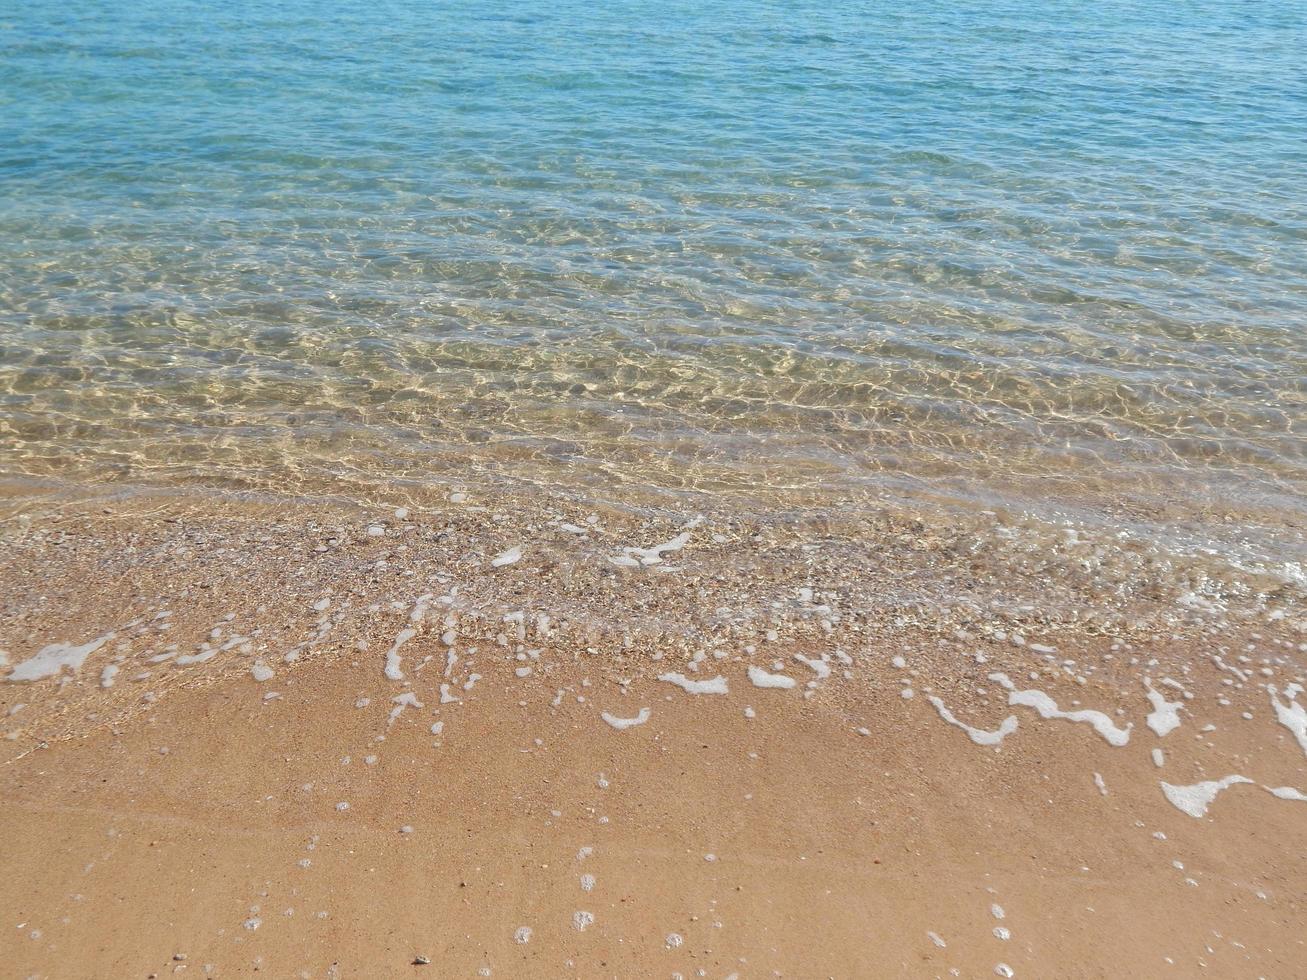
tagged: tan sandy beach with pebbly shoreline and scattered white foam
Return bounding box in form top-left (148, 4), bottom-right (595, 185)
top-left (0, 493), bottom-right (1307, 980)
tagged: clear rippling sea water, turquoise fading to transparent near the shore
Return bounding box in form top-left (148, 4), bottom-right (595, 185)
top-left (0, 0), bottom-right (1307, 540)
